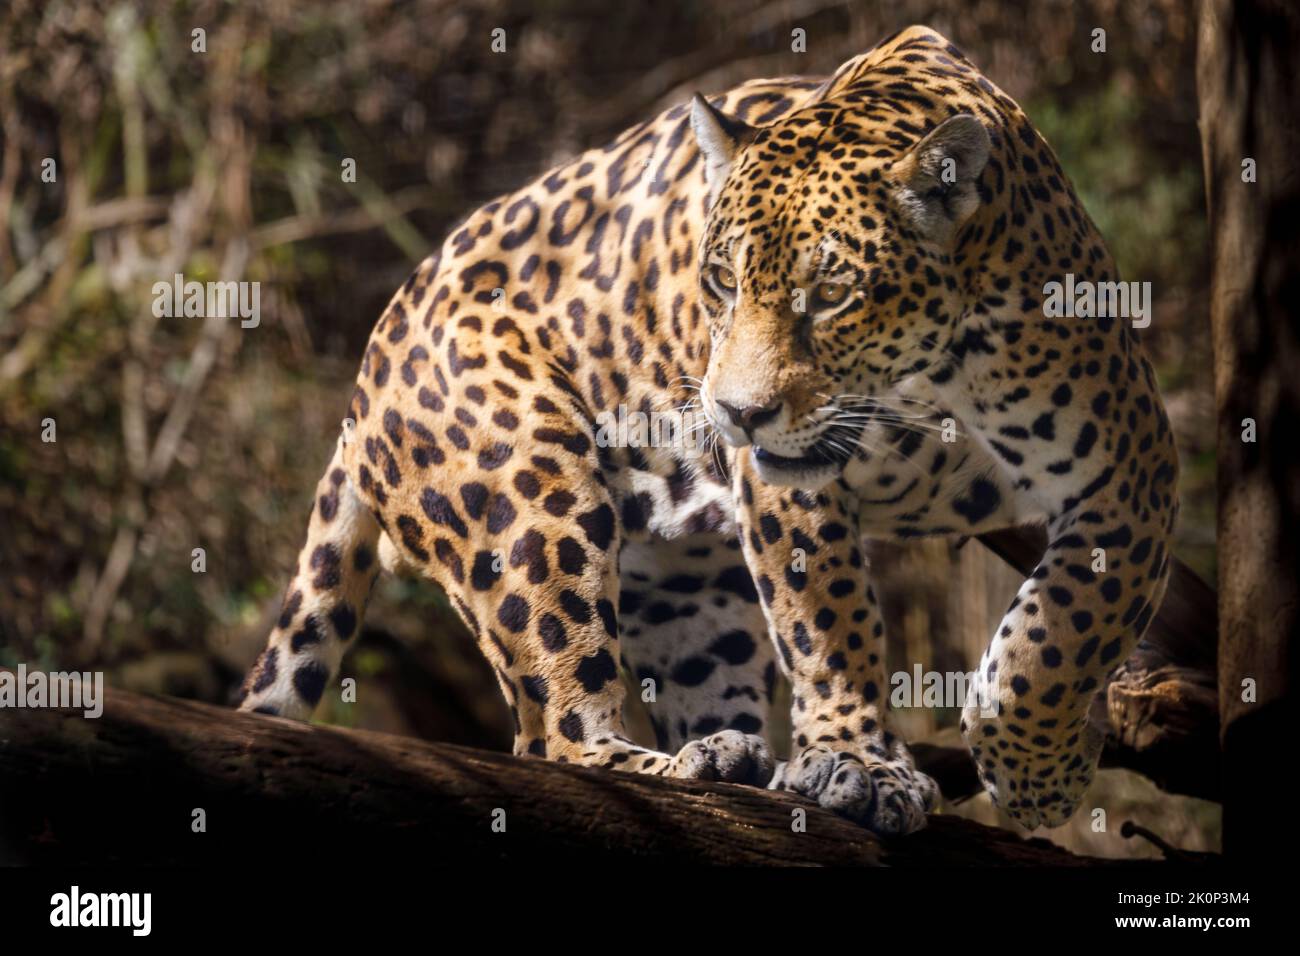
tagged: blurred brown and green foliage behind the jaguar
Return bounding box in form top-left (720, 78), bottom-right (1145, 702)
top-left (0, 0), bottom-right (1214, 853)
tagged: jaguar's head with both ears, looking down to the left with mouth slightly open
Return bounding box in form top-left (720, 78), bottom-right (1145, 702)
top-left (690, 95), bottom-right (989, 489)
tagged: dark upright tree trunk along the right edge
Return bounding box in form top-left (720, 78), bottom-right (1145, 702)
top-left (1196, 0), bottom-right (1300, 858)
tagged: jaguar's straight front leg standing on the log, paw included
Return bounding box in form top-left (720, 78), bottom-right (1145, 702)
top-left (736, 468), bottom-right (937, 834)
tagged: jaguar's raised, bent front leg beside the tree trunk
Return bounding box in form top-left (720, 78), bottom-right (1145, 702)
top-left (962, 496), bottom-right (1177, 830)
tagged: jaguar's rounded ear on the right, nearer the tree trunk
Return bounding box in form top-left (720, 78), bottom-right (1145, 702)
top-left (894, 113), bottom-right (991, 245)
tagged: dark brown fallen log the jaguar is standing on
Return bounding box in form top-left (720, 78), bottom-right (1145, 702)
top-left (0, 689), bottom-right (1159, 866)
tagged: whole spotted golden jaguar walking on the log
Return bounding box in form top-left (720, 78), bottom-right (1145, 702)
top-left (242, 27), bottom-right (1177, 832)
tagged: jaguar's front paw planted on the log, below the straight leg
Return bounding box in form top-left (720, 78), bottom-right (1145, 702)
top-left (772, 744), bottom-right (939, 836)
